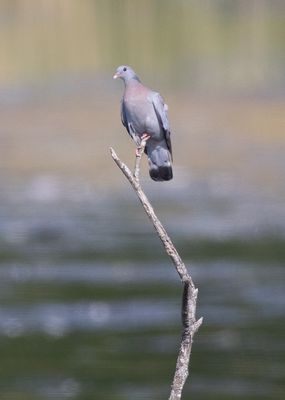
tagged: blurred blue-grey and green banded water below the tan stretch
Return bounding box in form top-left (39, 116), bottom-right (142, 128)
top-left (0, 176), bottom-right (285, 400)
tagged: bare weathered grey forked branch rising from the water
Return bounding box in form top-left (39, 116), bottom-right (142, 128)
top-left (110, 140), bottom-right (203, 400)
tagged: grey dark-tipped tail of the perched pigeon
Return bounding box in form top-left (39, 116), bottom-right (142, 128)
top-left (146, 145), bottom-right (173, 181)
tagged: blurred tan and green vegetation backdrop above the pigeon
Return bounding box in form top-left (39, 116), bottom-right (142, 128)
top-left (0, 0), bottom-right (285, 91)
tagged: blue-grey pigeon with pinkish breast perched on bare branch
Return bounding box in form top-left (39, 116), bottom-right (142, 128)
top-left (113, 65), bottom-right (173, 181)
